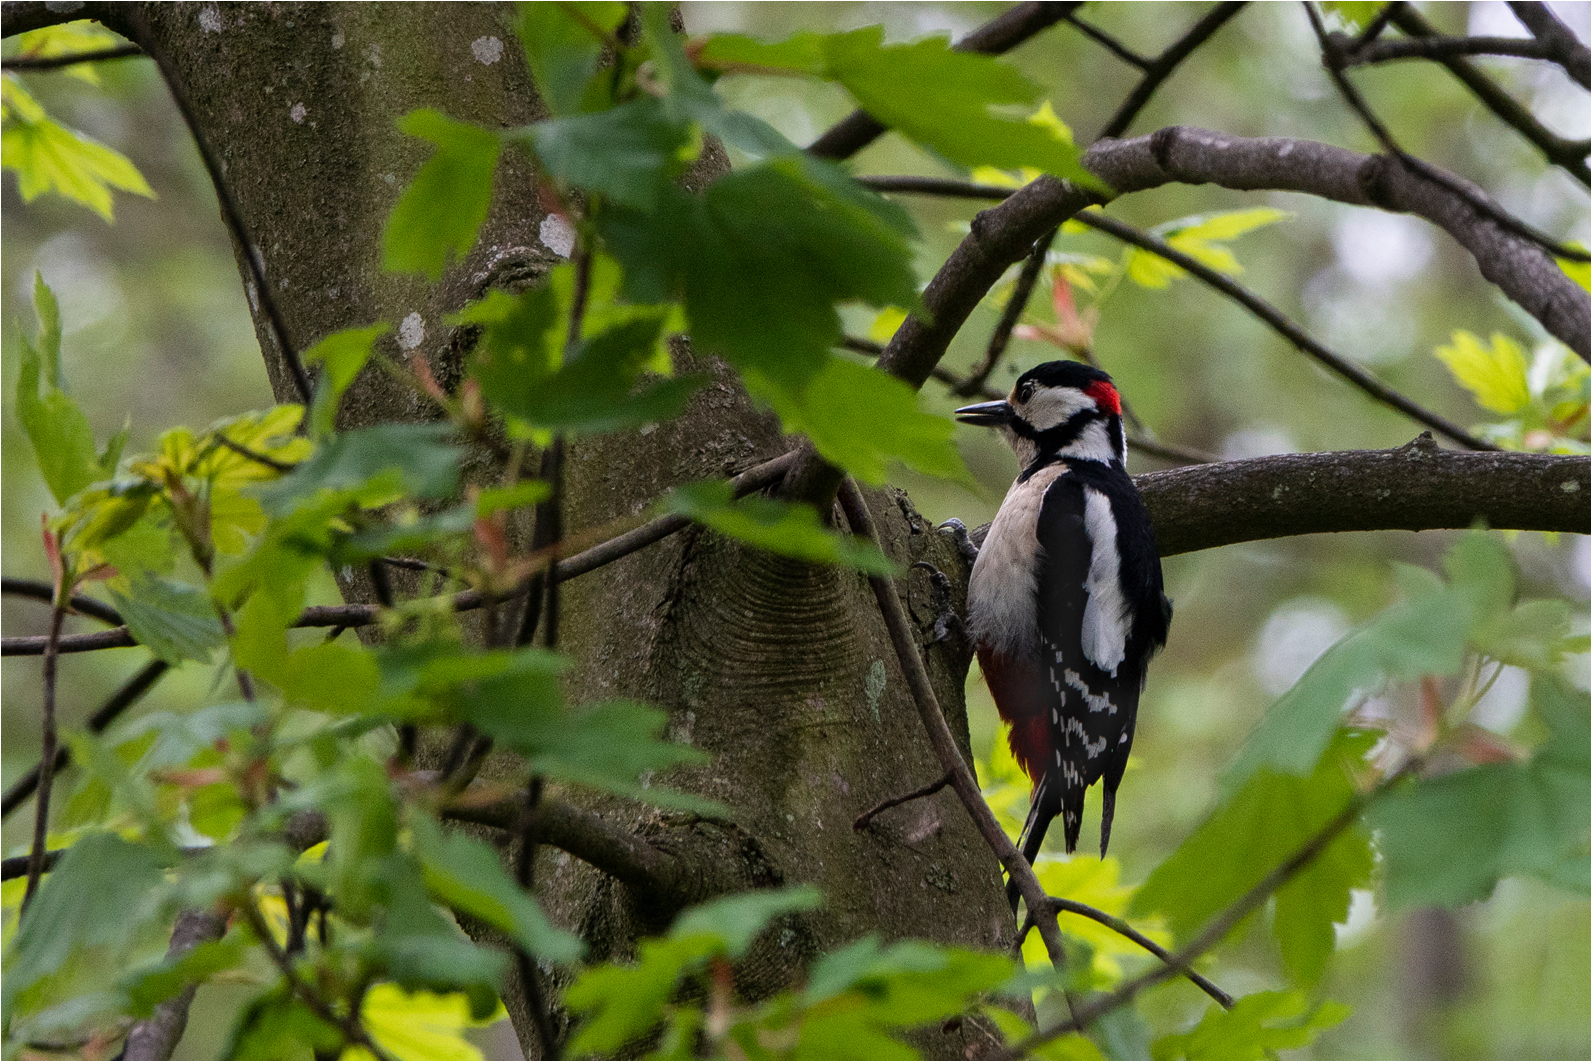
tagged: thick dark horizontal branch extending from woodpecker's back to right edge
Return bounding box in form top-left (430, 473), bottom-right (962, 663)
top-left (1134, 433), bottom-right (1593, 556)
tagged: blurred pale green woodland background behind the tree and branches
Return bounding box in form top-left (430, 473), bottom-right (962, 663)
top-left (0, 3), bottom-right (1593, 1058)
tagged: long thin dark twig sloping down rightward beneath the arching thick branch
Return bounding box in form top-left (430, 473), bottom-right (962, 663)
top-left (860, 177), bottom-right (1499, 451)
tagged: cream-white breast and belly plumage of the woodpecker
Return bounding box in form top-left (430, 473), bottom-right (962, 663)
top-left (969, 462), bottom-right (1064, 657)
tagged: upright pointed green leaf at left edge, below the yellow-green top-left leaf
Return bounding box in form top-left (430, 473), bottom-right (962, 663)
top-left (8, 274), bottom-right (105, 504)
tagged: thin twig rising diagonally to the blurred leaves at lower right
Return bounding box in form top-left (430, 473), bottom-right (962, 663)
top-left (1013, 757), bottom-right (1419, 1057)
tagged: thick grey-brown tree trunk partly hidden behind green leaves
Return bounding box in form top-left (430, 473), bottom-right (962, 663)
top-left (129, 3), bottom-right (1013, 1057)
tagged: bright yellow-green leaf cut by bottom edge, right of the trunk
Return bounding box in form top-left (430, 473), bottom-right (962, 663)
top-left (1155, 990), bottom-right (1349, 1060)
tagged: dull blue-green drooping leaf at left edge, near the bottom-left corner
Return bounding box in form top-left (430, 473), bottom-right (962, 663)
top-left (3, 834), bottom-right (164, 1012)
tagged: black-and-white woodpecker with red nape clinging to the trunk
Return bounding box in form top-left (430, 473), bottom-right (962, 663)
top-left (956, 362), bottom-right (1172, 908)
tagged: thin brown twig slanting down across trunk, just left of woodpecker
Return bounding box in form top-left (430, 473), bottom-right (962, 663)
top-left (840, 477), bottom-right (1067, 971)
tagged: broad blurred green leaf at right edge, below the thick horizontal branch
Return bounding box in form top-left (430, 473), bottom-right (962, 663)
top-left (1368, 676), bottom-right (1590, 908)
